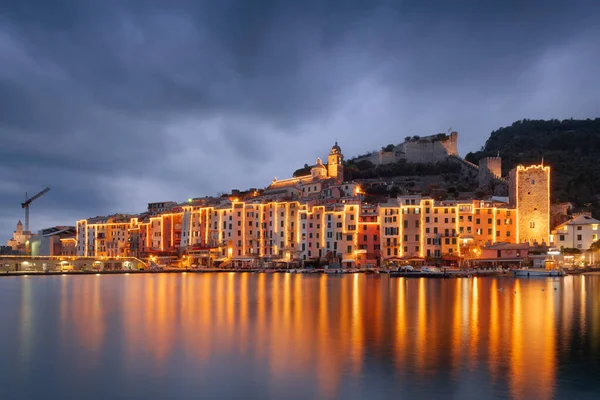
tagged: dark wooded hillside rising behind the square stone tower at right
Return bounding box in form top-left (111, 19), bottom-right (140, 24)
top-left (465, 118), bottom-right (600, 211)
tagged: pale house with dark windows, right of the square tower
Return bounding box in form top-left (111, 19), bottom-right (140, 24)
top-left (551, 214), bottom-right (600, 251)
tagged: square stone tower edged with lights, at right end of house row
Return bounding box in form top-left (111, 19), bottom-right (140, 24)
top-left (509, 164), bottom-right (550, 244)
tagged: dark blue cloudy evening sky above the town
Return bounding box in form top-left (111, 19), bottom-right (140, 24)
top-left (0, 0), bottom-right (600, 243)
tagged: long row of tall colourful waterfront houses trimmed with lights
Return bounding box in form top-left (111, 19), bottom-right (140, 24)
top-left (71, 196), bottom-right (536, 266)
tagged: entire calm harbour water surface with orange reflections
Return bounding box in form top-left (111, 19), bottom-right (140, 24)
top-left (0, 273), bottom-right (600, 400)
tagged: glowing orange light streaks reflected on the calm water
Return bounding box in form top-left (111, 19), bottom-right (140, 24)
top-left (48, 273), bottom-right (572, 399)
